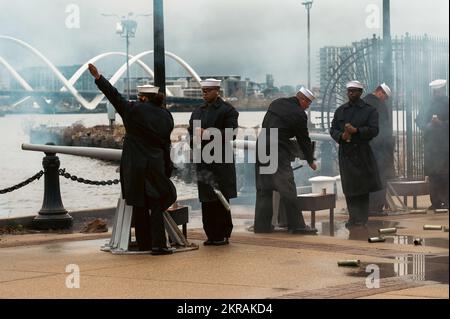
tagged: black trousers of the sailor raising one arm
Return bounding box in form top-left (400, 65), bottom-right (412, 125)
top-left (133, 198), bottom-right (167, 250)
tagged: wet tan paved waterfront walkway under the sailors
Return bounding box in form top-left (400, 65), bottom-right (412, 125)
top-left (0, 199), bottom-right (449, 299)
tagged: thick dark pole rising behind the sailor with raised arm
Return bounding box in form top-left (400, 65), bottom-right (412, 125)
top-left (153, 0), bottom-right (166, 102)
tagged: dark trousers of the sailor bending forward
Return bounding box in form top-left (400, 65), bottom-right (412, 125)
top-left (254, 190), bottom-right (306, 233)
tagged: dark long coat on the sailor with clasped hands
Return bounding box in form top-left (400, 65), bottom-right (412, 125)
top-left (330, 99), bottom-right (382, 196)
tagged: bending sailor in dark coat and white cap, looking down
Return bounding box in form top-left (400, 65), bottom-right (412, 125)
top-left (254, 88), bottom-right (317, 234)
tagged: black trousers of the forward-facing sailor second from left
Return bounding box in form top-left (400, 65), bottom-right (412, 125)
top-left (202, 199), bottom-right (233, 241)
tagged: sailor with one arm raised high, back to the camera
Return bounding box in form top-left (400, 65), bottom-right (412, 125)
top-left (89, 65), bottom-right (176, 254)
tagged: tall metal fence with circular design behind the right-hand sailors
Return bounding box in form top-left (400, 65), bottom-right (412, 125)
top-left (319, 33), bottom-right (449, 180)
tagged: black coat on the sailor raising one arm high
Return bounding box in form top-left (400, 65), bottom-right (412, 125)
top-left (95, 76), bottom-right (176, 211)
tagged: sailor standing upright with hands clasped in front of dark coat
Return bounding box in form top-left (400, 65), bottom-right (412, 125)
top-left (330, 81), bottom-right (382, 226)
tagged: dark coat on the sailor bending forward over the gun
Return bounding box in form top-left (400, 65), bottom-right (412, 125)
top-left (255, 97), bottom-right (314, 193)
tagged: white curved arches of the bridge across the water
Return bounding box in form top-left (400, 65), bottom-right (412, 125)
top-left (0, 35), bottom-right (201, 110)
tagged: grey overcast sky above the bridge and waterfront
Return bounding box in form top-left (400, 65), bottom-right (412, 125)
top-left (0, 0), bottom-right (449, 85)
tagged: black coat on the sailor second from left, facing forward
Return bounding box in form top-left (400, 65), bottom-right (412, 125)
top-left (188, 97), bottom-right (239, 202)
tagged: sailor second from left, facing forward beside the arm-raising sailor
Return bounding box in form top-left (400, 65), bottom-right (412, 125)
top-left (188, 79), bottom-right (239, 245)
